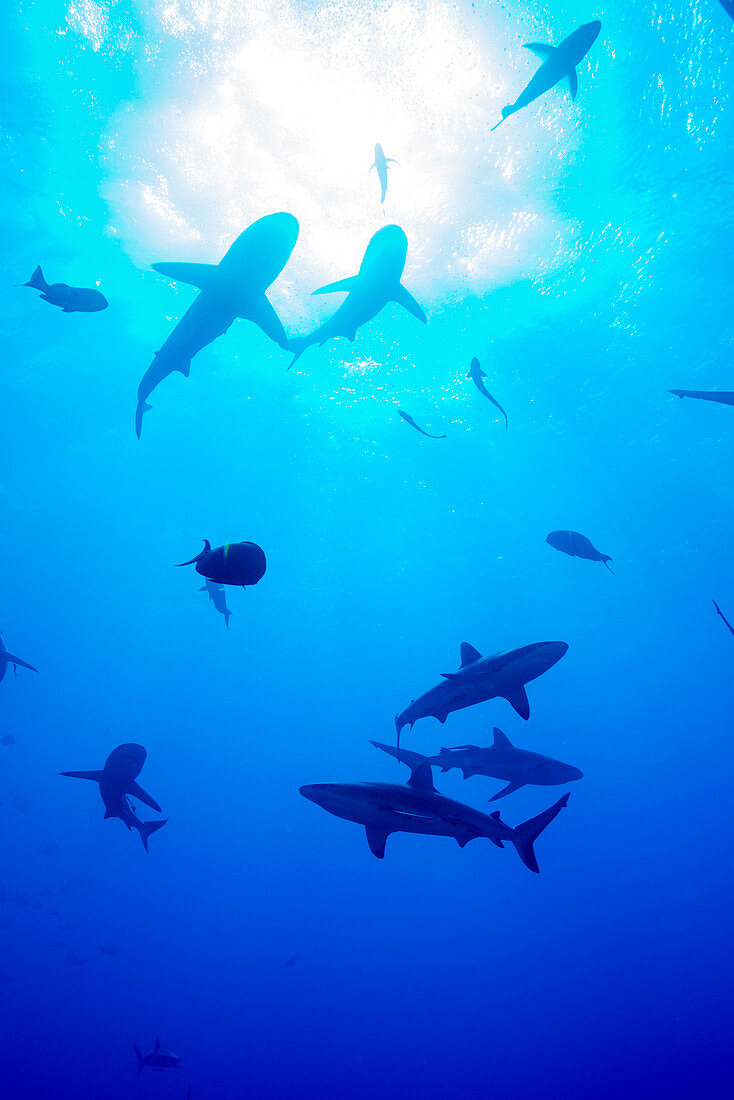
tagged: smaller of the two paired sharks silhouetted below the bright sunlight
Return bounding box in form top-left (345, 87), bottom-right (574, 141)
top-left (291, 226), bottom-right (426, 366)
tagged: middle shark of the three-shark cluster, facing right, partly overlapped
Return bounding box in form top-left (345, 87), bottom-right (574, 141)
top-left (371, 726), bottom-right (583, 802)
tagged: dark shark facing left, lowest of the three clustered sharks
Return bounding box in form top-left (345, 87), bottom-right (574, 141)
top-left (300, 761), bottom-right (568, 872)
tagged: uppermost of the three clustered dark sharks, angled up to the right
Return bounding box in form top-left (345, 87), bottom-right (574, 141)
top-left (395, 641), bottom-right (568, 747)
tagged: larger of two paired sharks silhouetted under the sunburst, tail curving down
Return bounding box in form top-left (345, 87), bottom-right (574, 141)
top-left (135, 213), bottom-right (298, 439)
